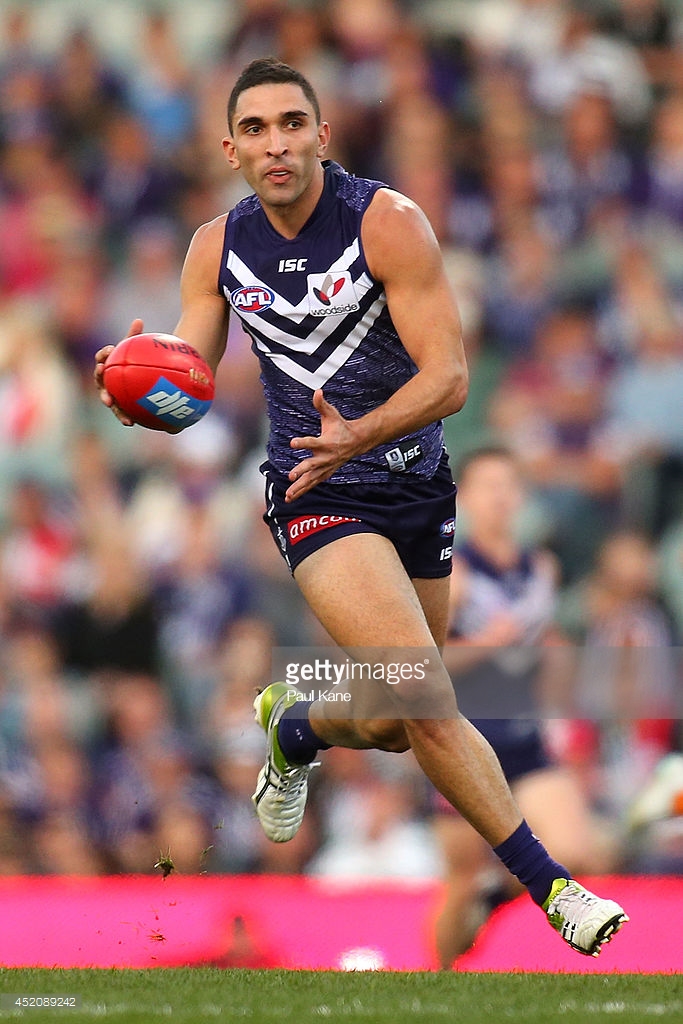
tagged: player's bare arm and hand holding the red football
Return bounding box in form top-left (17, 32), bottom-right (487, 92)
top-left (94, 214), bottom-right (229, 426)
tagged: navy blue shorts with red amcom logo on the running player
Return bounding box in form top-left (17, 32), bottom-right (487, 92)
top-left (261, 453), bottom-right (456, 580)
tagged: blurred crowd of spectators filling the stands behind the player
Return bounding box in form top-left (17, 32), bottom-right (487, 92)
top-left (0, 0), bottom-right (683, 876)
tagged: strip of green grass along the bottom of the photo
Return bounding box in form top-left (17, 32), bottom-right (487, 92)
top-left (0, 968), bottom-right (683, 1024)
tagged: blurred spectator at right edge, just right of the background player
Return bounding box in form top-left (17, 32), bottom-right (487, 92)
top-left (561, 530), bottom-right (680, 837)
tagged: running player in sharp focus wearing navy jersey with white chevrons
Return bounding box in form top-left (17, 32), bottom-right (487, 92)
top-left (95, 58), bottom-right (627, 954)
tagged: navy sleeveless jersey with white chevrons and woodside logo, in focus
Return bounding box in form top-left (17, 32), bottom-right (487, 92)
top-left (218, 161), bottom-right (443, 483)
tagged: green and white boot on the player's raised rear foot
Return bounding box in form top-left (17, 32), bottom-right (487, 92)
top-left (252, 683), bottom-right (313, 843)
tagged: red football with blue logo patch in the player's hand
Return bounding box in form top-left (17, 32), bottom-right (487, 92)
top-left (104, 334), bottom-right (215, 434)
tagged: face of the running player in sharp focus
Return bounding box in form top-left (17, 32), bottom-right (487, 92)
top-left (223, 83), bottom-right (330, 207)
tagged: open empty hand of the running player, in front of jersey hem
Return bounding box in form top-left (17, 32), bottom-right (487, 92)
top-left (285, 390), bottom-right (360, 502)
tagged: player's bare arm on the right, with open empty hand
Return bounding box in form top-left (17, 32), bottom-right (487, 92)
top-left (287, 189), bottom-right (468, 501)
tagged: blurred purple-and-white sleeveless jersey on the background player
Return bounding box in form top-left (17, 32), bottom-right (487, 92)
top-left (450, 544), bottom-right (555, 735)
